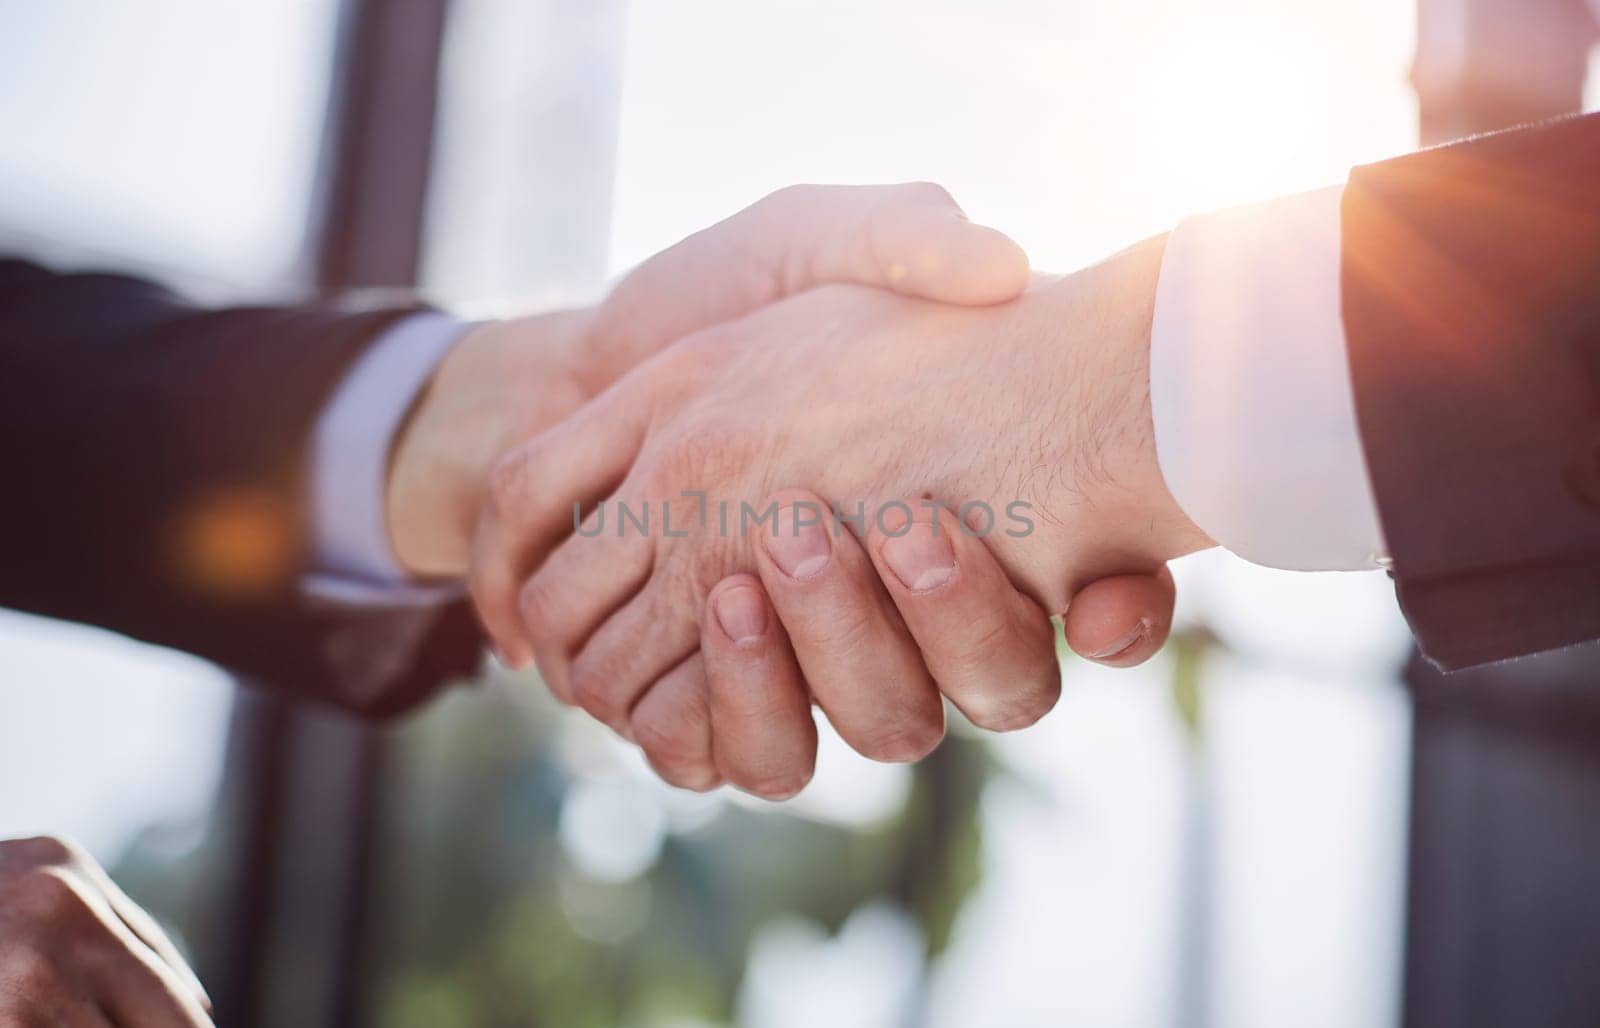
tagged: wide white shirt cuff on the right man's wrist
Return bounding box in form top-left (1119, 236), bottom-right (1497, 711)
top-left (1150, 187), bottom-right (1386, 570)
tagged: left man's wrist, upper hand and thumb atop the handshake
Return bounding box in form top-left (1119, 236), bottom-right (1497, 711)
top-left (387, 183), bottom-right (1029, 578)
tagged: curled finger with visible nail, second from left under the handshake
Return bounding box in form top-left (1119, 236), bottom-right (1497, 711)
top-left (755, 490), bottom-right (944, 761)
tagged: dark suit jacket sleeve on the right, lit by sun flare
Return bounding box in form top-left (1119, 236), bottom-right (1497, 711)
top-left (1342, 117), bottom-right (1600, 668)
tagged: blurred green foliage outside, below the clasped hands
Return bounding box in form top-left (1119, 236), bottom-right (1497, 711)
top-left (115, 666), bottom-right (992, 1028)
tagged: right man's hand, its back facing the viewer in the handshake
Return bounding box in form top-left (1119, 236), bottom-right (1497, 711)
top-left (474, 233), bottom-right (1211, 742)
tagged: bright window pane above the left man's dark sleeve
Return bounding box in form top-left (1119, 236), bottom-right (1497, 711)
top-left (0, 0), bottom-right (338, 293)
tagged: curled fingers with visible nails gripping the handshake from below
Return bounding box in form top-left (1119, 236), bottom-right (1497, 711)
top-left (627, 512), bottom-right (1173, 799)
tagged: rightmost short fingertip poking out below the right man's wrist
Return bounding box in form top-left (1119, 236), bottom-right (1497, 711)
top-left (1062, 567), bottom-right (1178, 668)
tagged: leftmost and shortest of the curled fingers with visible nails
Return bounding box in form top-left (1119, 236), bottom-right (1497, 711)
top-left (701, 575), bottom-right (816, 799)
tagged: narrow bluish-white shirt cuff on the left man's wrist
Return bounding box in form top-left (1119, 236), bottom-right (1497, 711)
top-left (302, 312), bottom-right (467, 607)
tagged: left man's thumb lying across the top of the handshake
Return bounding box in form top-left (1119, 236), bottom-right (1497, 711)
top-left (590, 183), bottom-right (1029, 368)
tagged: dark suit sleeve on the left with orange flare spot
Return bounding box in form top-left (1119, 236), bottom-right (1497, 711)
top-left (0, 261), bottom-right (478, 716)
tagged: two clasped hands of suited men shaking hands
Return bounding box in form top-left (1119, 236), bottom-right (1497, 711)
top-left (386, 184), bottom-right (1211, 797)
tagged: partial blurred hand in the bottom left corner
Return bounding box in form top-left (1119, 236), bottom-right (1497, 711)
top-left (0, 839), bottom-right (211, 1028)
